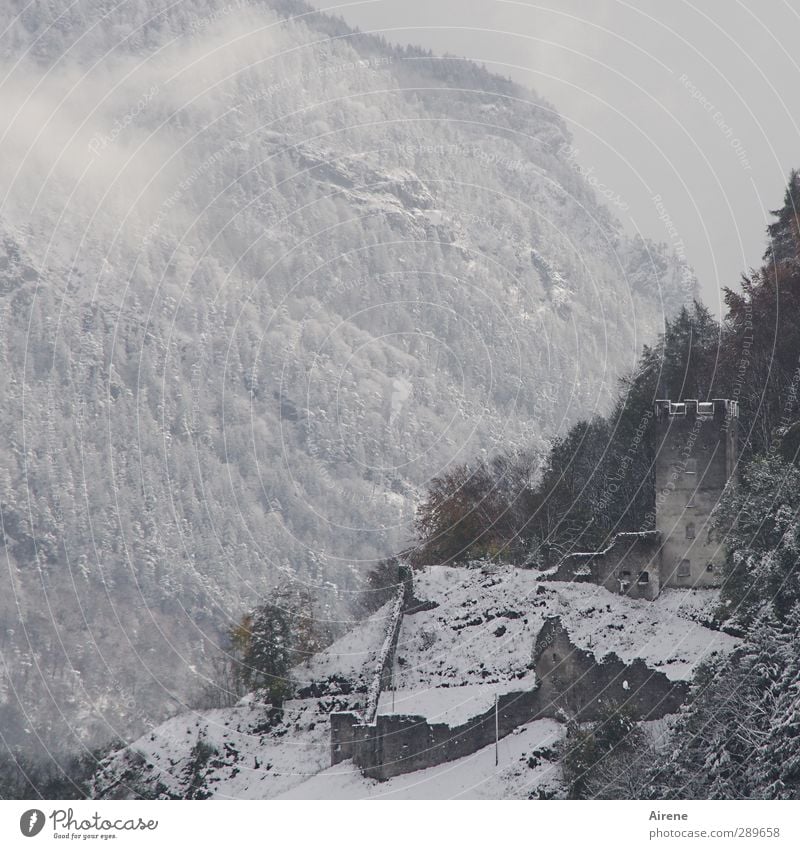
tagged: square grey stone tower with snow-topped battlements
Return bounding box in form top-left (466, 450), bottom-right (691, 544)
top-left (655, 398), bottom-right (739, 587)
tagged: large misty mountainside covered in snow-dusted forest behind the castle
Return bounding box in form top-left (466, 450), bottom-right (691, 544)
top-left (0, 0), bottom-right (694, 748)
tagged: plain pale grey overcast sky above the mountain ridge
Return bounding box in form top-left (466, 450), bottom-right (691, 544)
top-left (317, 0), bottom-right (800, 312)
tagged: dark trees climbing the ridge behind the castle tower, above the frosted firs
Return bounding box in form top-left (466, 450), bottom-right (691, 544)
top-left (413, 173), bottom-right (800, 565)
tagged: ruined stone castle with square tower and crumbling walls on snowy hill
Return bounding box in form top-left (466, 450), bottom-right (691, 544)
top-left (330, 399), bottom-right (738, 781)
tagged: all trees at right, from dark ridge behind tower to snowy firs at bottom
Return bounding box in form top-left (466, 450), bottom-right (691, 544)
top-left (413, 172), bottom-right (800, 799)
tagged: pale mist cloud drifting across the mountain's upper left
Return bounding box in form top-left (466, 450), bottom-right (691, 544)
top-left (0, 2), bottom-right (276, 274)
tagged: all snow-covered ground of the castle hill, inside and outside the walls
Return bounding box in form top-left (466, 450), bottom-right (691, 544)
top-left (90, 566), bottom-right (739, 799)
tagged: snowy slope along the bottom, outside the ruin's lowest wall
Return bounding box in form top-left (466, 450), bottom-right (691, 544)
top-left (95, 699), bottom-right (564, 799)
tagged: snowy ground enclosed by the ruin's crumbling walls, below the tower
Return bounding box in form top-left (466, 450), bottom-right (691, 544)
top-left (386, 566), bottom-right (737, 725)
